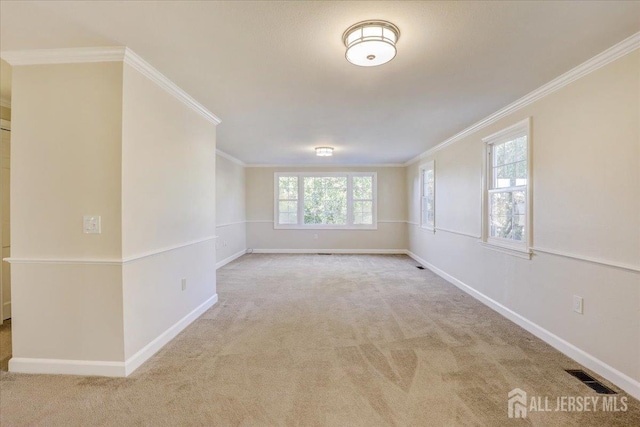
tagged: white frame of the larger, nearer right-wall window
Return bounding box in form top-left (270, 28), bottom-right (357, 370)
top-left (481, 117), bottom-right (533, 259)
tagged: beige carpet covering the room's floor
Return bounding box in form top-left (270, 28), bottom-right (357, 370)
top-left (0, 255), bottom-right (640, 426)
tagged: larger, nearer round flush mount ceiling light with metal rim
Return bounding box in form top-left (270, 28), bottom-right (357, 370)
top-left (342, 21), bottom-right (400, 67)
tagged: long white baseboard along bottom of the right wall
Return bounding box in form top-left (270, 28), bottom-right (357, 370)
top-left (406, 251), bottom-right (640, 399)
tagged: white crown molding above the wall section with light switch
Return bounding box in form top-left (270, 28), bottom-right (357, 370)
top-left (0, 46), bottom-right (126, 67)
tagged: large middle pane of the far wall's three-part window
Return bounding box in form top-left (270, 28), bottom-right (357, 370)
top-left (303, 177), bottom-right (347, 225)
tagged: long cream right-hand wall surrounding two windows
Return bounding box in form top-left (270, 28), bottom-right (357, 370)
top-left (407, 50), bottom-right (640, 397)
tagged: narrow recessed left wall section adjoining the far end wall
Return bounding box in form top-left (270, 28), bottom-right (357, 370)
top-left (216, 155), bottom-right (247, 268)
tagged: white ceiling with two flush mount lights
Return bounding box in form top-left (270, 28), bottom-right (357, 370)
top-left (0, 1), bottom-right (640, 164)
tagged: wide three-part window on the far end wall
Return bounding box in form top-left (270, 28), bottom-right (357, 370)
top-left (274, 173), bottom-right (377, 229)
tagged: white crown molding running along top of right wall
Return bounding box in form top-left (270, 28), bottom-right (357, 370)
top-left (404, 32), bottom-right (640, 166)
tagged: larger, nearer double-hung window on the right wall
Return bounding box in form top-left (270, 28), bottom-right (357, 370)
top-left (483, 119), bottom-right (531, 253)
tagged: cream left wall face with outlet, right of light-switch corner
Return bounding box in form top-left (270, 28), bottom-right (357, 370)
top-left (122, 63), bottom-right (216, 360)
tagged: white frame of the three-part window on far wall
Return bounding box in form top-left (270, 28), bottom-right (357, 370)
top-left (273, 172), bottom-right (378, 230)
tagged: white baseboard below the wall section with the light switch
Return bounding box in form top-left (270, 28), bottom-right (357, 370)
top-left (9, 357), bottom-right (126, 377)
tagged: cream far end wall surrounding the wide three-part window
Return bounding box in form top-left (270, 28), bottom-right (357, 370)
top-left (246, 166), bottom-right (408, 252)
